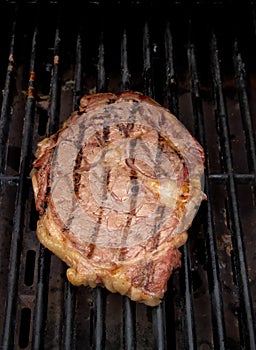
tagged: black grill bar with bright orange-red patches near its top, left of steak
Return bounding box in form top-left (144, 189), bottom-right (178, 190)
top-left (2, 16), bottom-right (38, 349)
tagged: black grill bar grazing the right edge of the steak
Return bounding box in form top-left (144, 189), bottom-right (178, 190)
top-left (188, 44), bottom-right (226, 350)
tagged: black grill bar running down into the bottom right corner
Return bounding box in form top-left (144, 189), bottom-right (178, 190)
top-left (211, 34), bottom-right (256, 349)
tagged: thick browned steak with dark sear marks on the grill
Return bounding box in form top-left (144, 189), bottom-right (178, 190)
top-left (31, 91), bottom-right (205, 306)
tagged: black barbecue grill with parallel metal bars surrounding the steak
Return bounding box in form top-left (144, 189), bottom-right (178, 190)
top-left (0, 0), bottom-right (256, 350)
